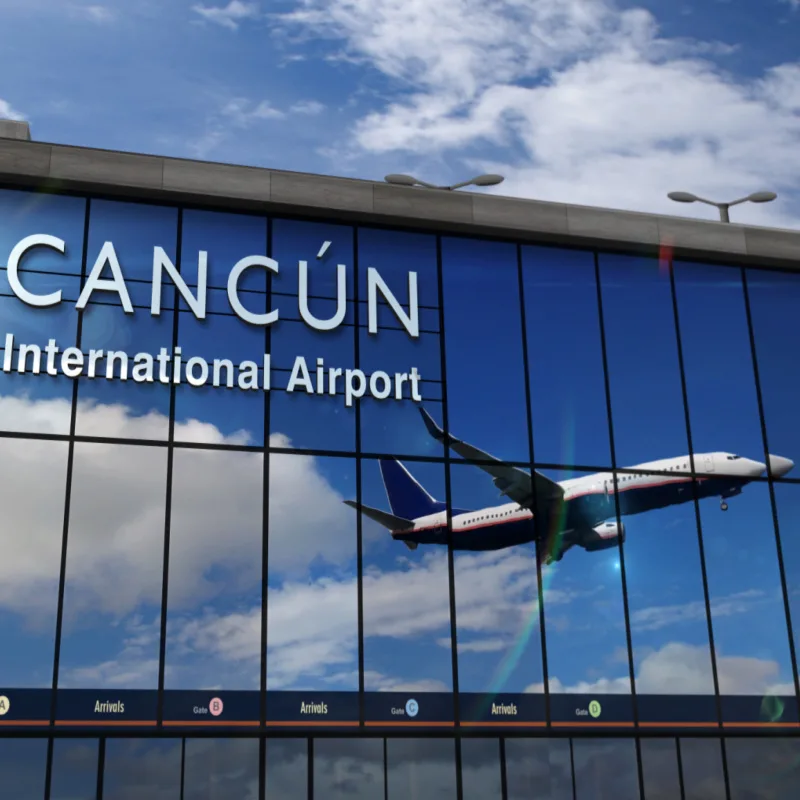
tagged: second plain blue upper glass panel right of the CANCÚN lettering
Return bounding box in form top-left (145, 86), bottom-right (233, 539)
top-left (522, 247), bottom-right (611, 466)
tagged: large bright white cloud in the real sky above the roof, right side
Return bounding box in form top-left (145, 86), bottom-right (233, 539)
top-left (284, 0), bottom-right (800, 225)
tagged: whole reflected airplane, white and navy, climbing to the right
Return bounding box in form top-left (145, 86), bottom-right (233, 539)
top-left (345, 409), bottom-right (794, 564)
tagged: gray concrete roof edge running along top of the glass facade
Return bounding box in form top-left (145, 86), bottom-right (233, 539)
top-left (0, 138), bottom-right (800, 268)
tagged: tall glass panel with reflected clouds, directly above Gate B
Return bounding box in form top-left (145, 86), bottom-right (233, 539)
top-left (165, 449), bottom-right (264, 690)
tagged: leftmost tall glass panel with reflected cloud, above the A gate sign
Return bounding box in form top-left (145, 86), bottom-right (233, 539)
top-left (0, 439), bottom-right (67, 688)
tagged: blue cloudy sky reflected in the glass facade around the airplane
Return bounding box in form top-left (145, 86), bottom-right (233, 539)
top-left (0, 191), bottom-right (800, 712)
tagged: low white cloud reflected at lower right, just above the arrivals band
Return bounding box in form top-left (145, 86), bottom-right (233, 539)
top-left (525, 642), bottom-right (794, 695)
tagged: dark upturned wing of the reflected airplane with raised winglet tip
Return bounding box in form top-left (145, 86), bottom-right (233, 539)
top-left (420, 408), bottom-right (564, 512)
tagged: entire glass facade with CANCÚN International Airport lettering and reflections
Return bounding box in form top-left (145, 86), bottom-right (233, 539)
top-left (0, 190), bottom-right (800, 800)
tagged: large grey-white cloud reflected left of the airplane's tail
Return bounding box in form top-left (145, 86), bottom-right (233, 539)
top-left (0, 397), bottom-right (355, 616)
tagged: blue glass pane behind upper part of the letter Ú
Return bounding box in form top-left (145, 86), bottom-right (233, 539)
top-left (272, 219), bottom-right (355, 300)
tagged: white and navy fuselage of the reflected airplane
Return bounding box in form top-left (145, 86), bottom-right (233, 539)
top-left (392, 453), bottom-right (763, 551)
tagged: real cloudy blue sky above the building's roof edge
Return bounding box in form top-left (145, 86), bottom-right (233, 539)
top-left (0, 0), bottom-right (800, 227)
